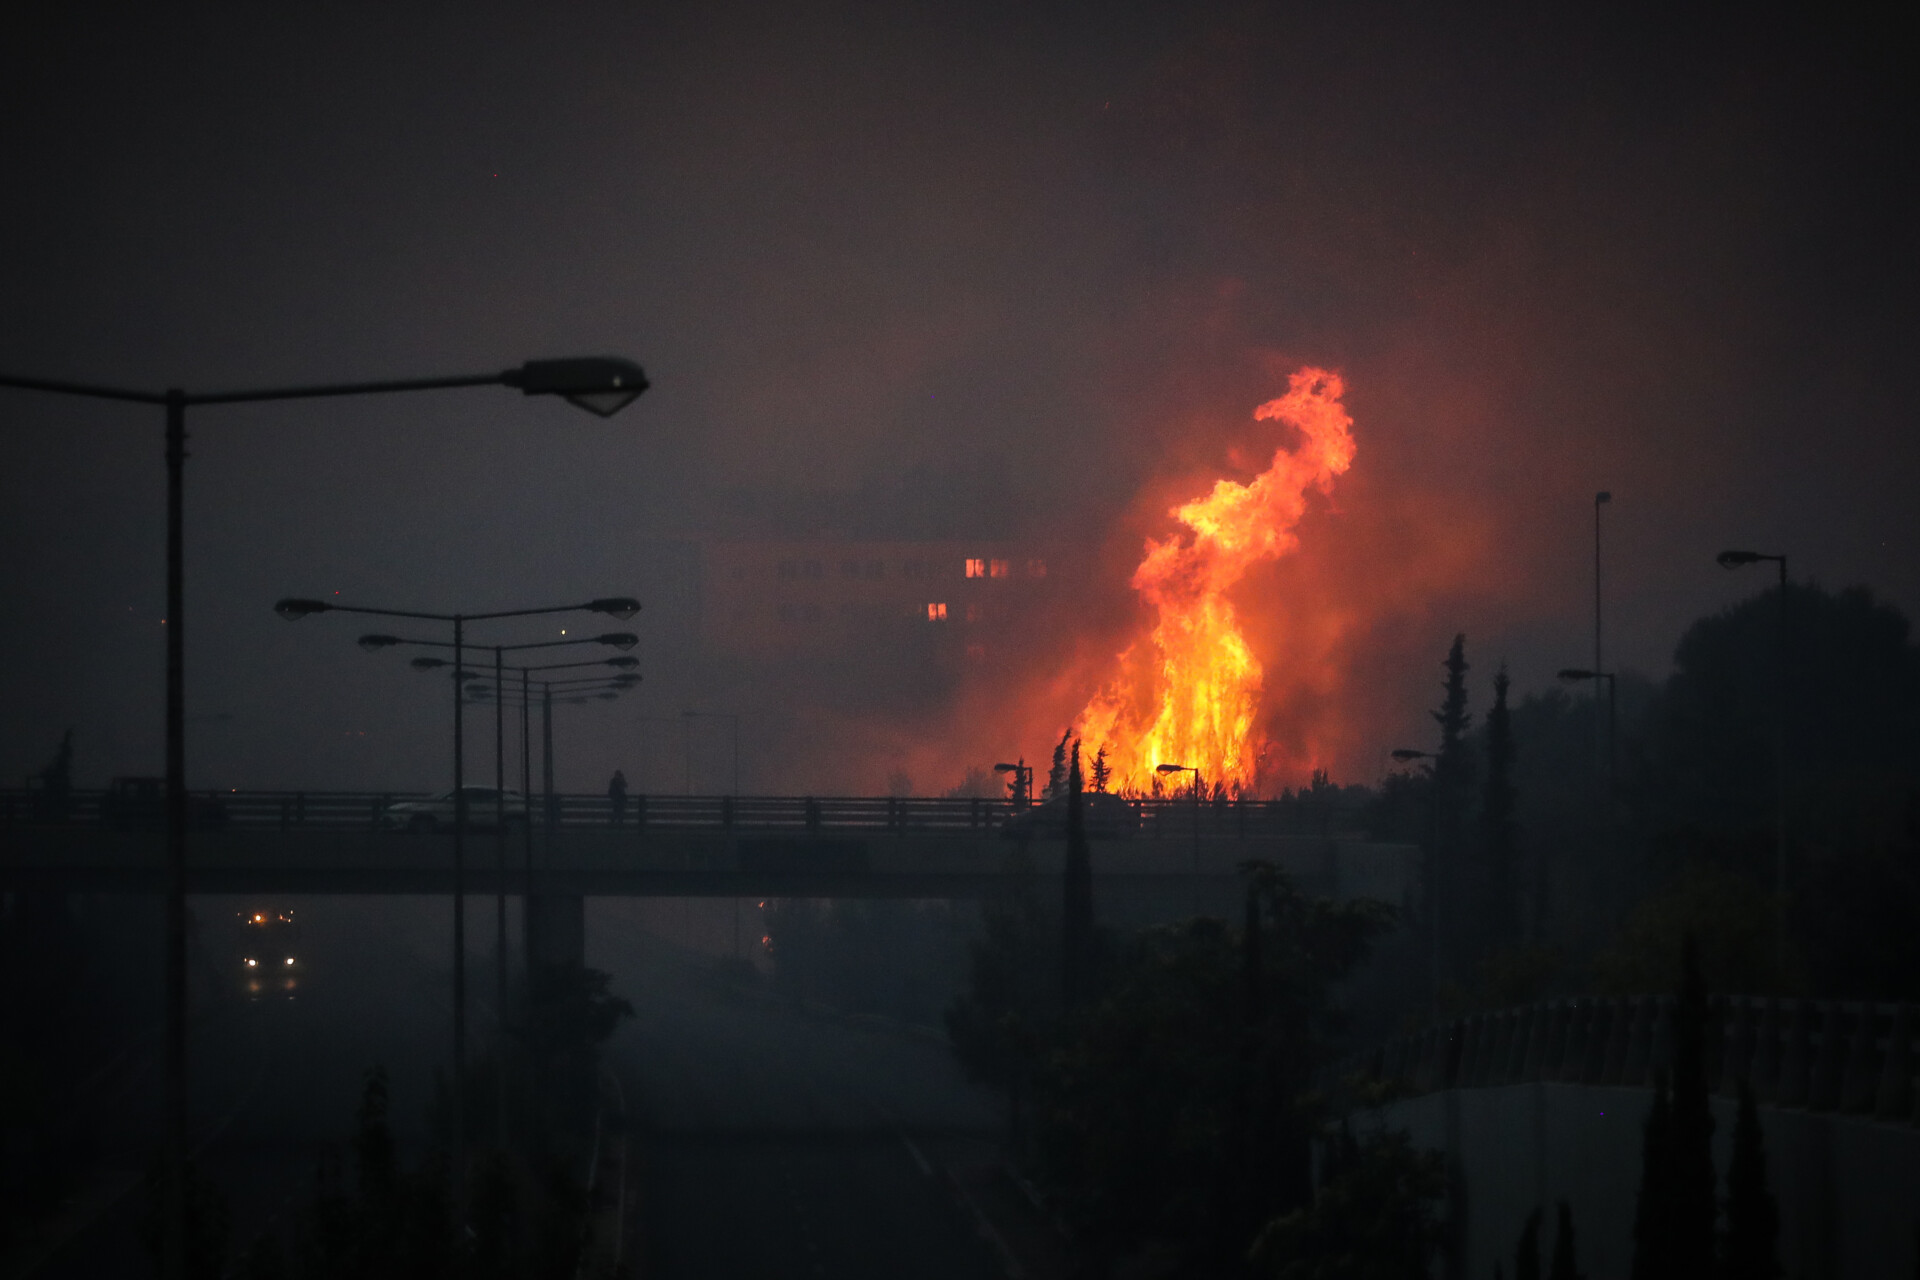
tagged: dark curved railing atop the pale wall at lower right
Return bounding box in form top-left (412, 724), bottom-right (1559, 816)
top-left (1319, 996), bottom-right (1920, 1125)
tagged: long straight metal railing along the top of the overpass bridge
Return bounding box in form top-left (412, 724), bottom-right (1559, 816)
top-left (0, 789), bottom-right (1356, 839)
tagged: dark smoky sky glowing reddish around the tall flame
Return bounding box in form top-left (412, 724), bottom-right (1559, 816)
top-left (0, 4), bottom-right (1920, 789)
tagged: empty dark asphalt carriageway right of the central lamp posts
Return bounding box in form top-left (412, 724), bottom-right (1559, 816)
top-left (588, 902), bottom-right (1002, 1280)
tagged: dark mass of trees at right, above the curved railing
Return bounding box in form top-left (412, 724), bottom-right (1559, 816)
top-left (1350, 585), bottom-right (1920, 1009)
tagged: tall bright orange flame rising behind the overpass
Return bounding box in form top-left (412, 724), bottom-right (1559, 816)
top-left (1075, 368), bottom-right (1354, 791)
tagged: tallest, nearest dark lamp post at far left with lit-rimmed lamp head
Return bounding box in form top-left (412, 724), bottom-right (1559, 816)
top-left (0, 357), bottom-right (647, 1278)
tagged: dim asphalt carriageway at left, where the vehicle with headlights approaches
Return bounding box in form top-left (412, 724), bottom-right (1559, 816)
top-left (19, 898), bottom-right (460, 1280)
